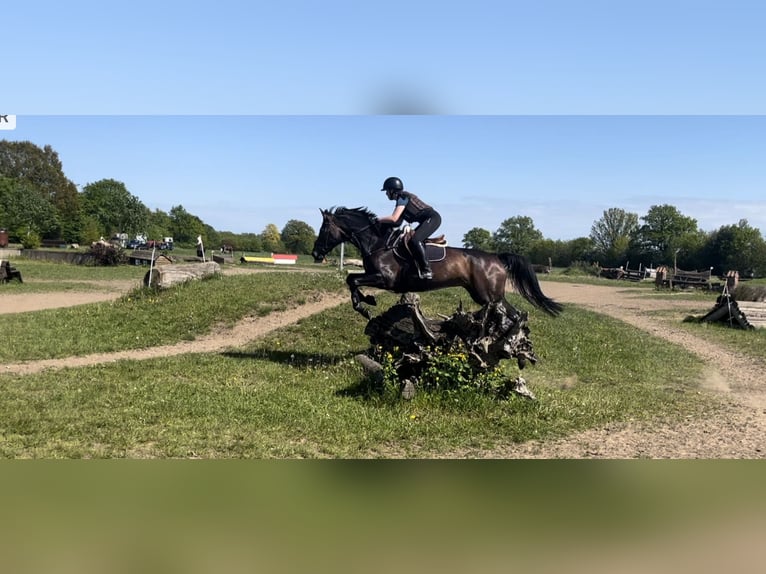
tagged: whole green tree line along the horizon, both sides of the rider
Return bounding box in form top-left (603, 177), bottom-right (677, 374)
top-left (0, 140), bottom-right (766, 276)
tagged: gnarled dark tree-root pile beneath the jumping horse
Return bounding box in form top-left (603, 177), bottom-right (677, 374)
top-left (357, 293), bottom-right (538, 399)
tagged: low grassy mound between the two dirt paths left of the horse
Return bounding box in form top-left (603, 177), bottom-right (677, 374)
top-left (0, 272), bottom-right (346, 361)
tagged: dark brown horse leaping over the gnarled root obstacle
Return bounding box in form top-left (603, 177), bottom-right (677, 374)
top-left (312, 207), bottom-right (563, 319)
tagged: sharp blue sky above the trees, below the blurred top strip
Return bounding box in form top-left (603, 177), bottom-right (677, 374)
top-left (6, 115), bottom-right (766, 244)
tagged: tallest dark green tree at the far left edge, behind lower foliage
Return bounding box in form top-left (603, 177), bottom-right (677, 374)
top-left (0, 140), bottom-right (82, 241)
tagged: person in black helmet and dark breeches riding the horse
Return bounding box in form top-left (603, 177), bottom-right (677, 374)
top-left (378, 177), bottom-right (442, 279)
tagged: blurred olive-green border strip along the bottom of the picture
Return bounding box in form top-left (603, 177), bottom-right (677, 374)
top-left (0, 460), bottom-right (766, 574)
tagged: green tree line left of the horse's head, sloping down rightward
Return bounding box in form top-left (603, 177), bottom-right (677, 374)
top-left (0, 140), bottom-right (316, 253)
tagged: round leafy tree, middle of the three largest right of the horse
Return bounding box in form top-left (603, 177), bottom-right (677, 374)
top-left (634, 205), bottom-right (699, 264)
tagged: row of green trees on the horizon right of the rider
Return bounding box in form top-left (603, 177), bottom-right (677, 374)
top-left (463, 208), bottom-right (766, 277)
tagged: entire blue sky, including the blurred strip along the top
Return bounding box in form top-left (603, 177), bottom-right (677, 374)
top-left (0, 0), bottom-right (766, 245)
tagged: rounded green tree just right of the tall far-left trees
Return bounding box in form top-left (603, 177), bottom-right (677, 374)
top-left (81, 179), bottom-right (149, 237)
